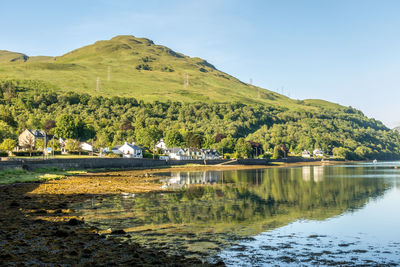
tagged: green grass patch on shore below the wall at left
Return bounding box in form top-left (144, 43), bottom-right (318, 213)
top-left (0, 168), bottom-right (86, 184)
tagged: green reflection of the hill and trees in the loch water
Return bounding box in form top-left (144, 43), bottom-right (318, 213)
top-left (73, 166), bottom-right (388, 260)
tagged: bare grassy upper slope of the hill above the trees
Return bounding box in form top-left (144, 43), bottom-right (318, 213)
top-left (0, 36), bottom-right (324, 109)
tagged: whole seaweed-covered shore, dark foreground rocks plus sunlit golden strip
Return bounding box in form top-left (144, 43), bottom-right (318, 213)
top-left (0, 163), bottom-right (340, 266)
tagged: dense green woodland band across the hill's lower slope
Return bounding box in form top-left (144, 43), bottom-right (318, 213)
top-left (0, 78), bottom-right (400, 159)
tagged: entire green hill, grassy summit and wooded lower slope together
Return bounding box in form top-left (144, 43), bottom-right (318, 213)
top-left (0, 36), bottom-right (400, 160)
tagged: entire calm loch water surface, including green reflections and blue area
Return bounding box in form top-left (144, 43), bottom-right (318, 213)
top-left (75, 162), bottom-right (400, 266)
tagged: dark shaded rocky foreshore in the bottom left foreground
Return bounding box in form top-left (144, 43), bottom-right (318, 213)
top-left (0, 178), bottom-right (223, 266)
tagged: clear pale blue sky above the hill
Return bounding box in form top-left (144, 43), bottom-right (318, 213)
top-left (0, 0), bottom-right (400, 127)
